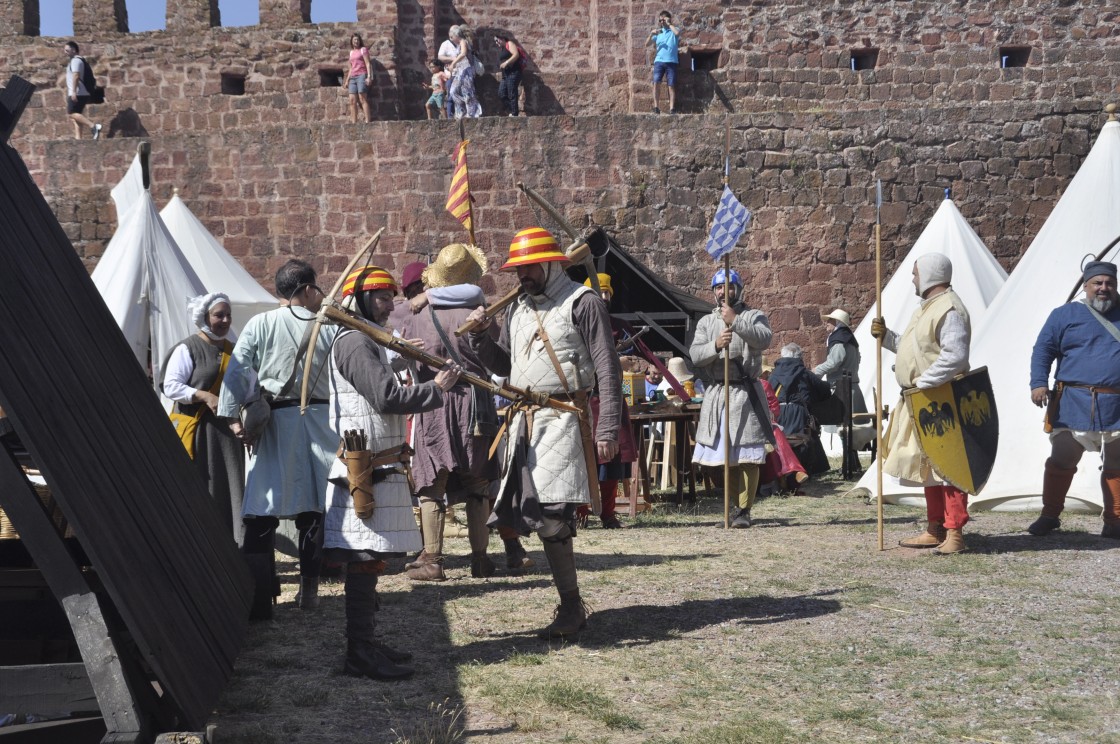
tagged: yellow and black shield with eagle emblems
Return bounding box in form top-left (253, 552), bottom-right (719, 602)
top-left (906, 366), bottom-right (999, 495)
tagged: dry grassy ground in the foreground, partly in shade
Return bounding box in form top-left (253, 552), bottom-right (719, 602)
top-left (212, 466), bottom-right (1120, 744)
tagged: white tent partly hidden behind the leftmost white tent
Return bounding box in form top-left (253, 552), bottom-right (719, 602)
top-left (159, 189), bottom-right (280, 334)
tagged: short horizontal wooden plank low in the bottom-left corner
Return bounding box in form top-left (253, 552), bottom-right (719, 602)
top-left (0, 663), bottom-right (99, 715)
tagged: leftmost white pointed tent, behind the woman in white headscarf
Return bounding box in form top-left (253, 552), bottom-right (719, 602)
top-left (92, 155), bottom-right (206, 381)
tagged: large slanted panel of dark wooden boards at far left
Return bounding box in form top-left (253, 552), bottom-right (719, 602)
top-left (0, 133), bottom-right (250, 727)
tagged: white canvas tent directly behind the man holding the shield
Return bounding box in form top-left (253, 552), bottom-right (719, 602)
top-left (851, 198), bottom-right (1007, 504)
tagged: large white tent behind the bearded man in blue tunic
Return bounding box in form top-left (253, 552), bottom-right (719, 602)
top-left (971, 120), bottom-right (1120, 512)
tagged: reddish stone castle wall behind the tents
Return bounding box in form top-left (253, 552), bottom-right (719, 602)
top-left (0, 0), bottom-right (1120, 360)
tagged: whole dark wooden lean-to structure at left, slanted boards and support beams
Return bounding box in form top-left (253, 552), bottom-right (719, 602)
top-left (0, 78), bottom-right (251, 744)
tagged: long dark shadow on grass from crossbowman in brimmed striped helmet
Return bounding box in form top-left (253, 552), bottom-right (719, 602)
top-left (456, 589), bottom-right (841, 663)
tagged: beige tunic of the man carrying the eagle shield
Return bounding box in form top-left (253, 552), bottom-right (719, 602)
top-left (883, 289), bottom-right (969, 485)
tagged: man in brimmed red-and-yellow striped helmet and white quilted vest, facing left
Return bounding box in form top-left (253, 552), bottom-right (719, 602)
top-left (468, 227), bottom-right (622, 639)
